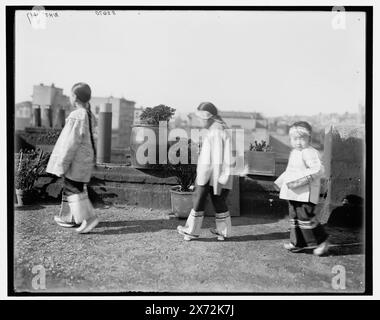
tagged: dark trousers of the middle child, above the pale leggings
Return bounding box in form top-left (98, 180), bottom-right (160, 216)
top-left (193, 184), bottom-right (230, 213)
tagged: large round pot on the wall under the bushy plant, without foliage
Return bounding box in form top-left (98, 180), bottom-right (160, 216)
top-left (130, 124), bottom-right (167, 169)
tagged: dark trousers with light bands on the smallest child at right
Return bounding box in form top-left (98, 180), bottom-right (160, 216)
top-left (289, 201), bottom-right (328, 248)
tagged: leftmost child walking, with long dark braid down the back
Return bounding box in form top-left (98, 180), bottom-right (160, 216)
top-left (46, 82), bottom-right (99, 233)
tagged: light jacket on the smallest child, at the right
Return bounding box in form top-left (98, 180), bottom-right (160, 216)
top-left (275, 147), bottom-right (324, 204)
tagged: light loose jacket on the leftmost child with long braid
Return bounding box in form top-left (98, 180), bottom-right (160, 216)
top-left (46, 108), bottom-right (95, 183)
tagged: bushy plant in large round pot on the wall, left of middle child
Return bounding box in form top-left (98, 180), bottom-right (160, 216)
top-left (130, 104), bottom-right (175, 169)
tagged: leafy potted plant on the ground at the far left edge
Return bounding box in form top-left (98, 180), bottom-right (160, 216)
top-left (15, 150), bottom-right (49, 206)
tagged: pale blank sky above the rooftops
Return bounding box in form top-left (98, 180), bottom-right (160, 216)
top-left (15, 11), bottom-right (365, 116)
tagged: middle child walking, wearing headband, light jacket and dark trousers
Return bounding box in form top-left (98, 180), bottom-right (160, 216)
top-left (177, 102), bottom-right (232, 241)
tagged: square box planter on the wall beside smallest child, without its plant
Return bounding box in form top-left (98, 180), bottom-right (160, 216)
top-left (244, 151), bottom-right (276, 176)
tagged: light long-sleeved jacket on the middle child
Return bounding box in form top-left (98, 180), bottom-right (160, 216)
top-left (196, 121), bottom-right (232, 195)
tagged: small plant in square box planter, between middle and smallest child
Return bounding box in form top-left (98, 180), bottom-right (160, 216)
top-left (245, 140), bottom-right (276, 176)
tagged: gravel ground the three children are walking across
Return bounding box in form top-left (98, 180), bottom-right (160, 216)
top-left (14, 204), bottom-right (364, 293)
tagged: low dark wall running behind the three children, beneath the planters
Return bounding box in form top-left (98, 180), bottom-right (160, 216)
top-left (36, 164), bottom-right (287, 216)
